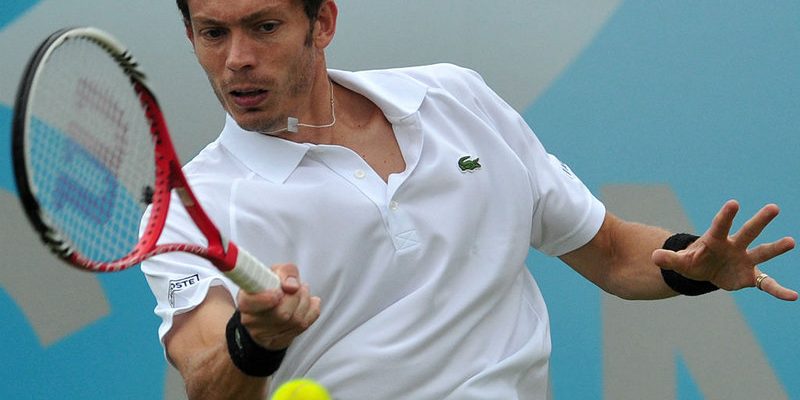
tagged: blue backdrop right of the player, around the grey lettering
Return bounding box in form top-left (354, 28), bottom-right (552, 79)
top-left (524, 1), bottom-right (800, 399)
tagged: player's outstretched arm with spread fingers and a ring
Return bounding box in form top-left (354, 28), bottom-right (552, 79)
top-left (561, 201), bottom-right (798, 301)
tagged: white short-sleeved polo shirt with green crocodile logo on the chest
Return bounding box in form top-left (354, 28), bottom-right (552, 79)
top-left (142, 65), bottom-right (605, 400)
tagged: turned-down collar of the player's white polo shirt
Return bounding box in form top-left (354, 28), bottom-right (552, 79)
top-left (220, 70), bottom-right (428, 183)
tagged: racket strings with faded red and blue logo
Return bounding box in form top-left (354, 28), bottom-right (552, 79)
top-left (28, 38), bottom-right (155, 262)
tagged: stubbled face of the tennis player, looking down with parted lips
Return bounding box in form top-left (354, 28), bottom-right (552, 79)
top-left (187, 0), bottom-right (317, 132)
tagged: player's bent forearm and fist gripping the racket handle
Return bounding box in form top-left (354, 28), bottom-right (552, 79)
top-left (164, 264), bottom-right (320, 400)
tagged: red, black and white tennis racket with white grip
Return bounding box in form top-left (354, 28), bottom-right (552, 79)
top-left (12, 27), bottom-right (280, 293)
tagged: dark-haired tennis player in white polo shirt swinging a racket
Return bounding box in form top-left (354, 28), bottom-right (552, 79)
top-left (142, 0), bottom-right (797, 400)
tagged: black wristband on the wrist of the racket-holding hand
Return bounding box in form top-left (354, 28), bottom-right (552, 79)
top-left (225, 310), bottom-right (286, 377)
